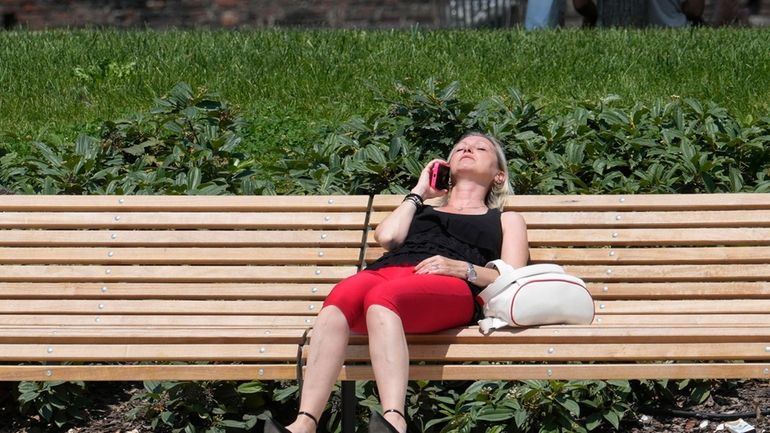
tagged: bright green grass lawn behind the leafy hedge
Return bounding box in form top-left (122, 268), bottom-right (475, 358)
top-left (0, 28), bottom-right (770, 157)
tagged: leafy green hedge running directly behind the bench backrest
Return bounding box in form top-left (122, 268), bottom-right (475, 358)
top-left (0, 80), bottom-right (770, 194)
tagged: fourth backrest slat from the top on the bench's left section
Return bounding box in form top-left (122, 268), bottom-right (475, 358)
top-left (0, 247), bottom-right (360, 266)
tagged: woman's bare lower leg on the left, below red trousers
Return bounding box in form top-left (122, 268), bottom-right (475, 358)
top-left (286, 306), bottom-right (350, 433)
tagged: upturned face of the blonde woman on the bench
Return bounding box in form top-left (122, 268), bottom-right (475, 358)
top-left (449, 135), bottom-right (504, 184)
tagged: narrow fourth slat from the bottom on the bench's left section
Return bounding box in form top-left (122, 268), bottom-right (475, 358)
top-left (0, 312), bottom-right (315, 329)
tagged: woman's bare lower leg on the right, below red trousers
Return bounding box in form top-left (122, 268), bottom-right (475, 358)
top-left (366, 305), bottom-right (409, 432)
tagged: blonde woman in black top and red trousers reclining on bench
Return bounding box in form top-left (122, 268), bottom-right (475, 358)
top-left (265, 133), bottom-right (529, 433)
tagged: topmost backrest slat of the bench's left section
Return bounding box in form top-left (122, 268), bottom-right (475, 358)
top-left (0, 195), bottom-right (369, 212)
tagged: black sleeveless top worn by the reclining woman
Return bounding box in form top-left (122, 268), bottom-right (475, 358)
top-left (366, 206), bottom-right (503, 298)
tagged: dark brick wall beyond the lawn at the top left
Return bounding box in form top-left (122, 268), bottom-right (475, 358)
top-left (0, 0), bottom-right (448, 29)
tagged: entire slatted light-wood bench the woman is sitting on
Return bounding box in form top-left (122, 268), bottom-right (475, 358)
top-left (0, 194), bottom-right (770, 381)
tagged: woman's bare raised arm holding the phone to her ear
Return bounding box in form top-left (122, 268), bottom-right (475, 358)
top-left (374, 159), bottom-right (446, 251)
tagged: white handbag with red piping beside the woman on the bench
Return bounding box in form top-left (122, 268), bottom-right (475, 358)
top-left (476, 260), bottom-right (594, 335)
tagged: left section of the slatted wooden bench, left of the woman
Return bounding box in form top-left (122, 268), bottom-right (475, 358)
top-left (0, 196), bottom-right (370, 380)
